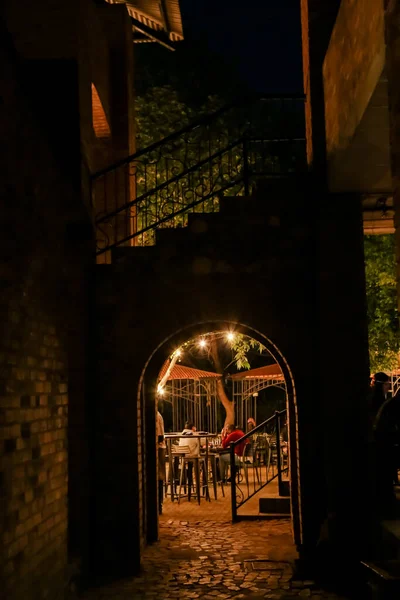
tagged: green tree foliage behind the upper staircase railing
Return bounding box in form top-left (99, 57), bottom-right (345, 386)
top-left (132, 63), bottom-right (304, 245)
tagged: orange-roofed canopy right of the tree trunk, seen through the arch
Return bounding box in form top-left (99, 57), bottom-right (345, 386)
top-left (229, 363), bottom-right (286, 427)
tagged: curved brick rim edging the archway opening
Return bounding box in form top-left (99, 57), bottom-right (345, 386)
top-left (138, 321), bottom-right (302, 546)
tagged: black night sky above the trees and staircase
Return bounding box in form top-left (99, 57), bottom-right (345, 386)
top-left (180, 0), bottom-right (302, 93)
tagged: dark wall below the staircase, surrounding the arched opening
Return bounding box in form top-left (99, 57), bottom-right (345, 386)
top-left (94, 182), bottom-right (330, 572)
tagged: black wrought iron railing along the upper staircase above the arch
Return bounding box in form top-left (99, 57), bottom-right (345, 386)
top-left (92, 96), bottom-right (306, 256)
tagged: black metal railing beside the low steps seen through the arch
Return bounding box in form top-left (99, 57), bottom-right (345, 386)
top-left (230, 409), bottom-right (289, 521)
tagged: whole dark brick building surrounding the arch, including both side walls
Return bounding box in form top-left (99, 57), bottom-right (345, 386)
top-left (0, 0), bottom-right (400, 600)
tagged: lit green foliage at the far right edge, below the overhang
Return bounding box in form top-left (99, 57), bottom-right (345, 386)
top-left (364, 235), bottom-right (400, 372)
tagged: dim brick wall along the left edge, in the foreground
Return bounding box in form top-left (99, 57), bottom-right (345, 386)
top-left (0, 28), bottom-right (91, 600)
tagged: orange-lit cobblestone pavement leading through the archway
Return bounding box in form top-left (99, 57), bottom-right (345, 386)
top-left (84, 516), bottom-right (352, 600)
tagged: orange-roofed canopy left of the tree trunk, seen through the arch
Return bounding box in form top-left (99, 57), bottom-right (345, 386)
top-left (159, 361), bottom-right (222, 432)
